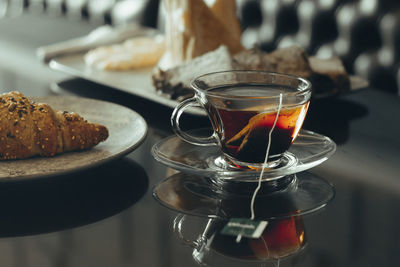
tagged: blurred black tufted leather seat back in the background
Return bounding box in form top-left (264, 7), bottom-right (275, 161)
top-left (0, 0), bottom-right (400, 95)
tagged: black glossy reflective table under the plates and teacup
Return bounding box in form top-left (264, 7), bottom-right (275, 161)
top-left (0, 16), bottom-right (400, 267)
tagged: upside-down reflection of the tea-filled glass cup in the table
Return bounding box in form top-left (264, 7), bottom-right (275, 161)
top-left (173, 214), bottom-right (307, 266)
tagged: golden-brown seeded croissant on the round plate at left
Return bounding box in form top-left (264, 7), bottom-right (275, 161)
top-left (0, 91), bottom-right (108, 160)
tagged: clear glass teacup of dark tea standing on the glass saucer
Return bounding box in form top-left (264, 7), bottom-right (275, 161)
top-left (171, 71), bottom-right (311, 167)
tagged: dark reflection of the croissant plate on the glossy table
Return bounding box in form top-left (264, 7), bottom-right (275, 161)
top-left (0, 159), bottom-right (148, 237)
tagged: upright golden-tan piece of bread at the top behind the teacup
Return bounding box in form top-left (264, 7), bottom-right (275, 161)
top-left (165, 0), bottom-right (244, 66)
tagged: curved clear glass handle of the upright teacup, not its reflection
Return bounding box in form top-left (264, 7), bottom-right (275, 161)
top-left (171, 97), bottom-right (217, 146)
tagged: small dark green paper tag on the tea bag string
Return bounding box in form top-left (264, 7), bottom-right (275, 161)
top-left (221, 218), bottom-right (268, 240)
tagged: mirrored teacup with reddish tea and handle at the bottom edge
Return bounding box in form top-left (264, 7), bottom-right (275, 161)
top-left (174, 215), bottom-right (307, 264)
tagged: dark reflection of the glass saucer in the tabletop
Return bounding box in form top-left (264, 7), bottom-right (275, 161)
top-left (153, 172), bottom-right (335, 220)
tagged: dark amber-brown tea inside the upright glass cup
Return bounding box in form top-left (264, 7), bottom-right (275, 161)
top-left (206, 86), bottom-right (309, 163)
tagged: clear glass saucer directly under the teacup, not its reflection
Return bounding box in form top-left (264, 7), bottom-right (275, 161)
top-left (152, 129), bottom-right (336, 182)
